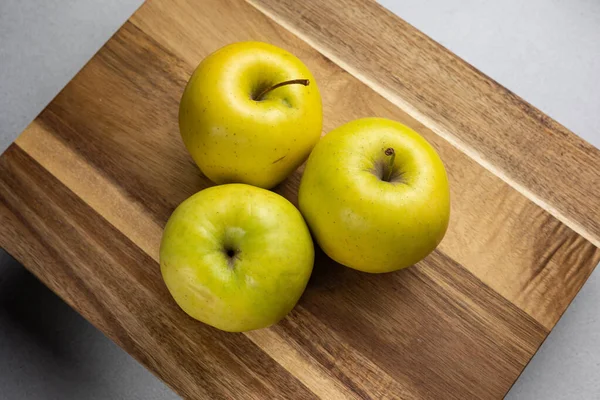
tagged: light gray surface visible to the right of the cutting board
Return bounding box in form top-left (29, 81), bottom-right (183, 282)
top-left (380, 0), bottom-right (600, 399)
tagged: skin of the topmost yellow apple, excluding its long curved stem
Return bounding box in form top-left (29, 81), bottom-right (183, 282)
top-left (179, 42), bottom-right (323, 189)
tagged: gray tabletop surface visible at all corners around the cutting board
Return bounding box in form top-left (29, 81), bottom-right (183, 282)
top-left (0, 0), bottom-right (600, 399)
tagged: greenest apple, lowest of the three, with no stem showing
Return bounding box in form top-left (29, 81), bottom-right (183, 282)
top-left (160, 184), bottom-right (314, 332)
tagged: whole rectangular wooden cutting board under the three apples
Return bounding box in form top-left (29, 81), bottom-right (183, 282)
top-left (0, 0), bottom-right (600, 399)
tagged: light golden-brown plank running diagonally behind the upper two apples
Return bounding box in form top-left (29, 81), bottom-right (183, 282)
top-left (127, 2), bottom-right (597, 328)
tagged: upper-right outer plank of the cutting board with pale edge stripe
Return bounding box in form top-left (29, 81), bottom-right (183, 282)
top-left (248, 0), bottom-right (600, 246)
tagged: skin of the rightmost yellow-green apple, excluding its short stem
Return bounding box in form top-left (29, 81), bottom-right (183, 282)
top-left (298, 118), bottom-right (450, 273)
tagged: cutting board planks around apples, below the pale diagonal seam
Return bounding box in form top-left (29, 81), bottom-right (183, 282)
top-left (0, 0), bottom-right (600, 399)
